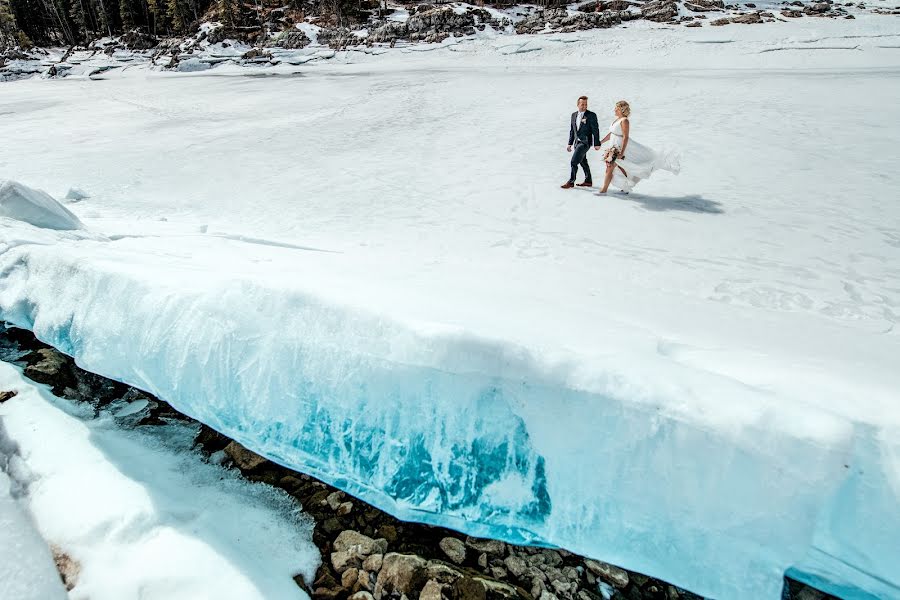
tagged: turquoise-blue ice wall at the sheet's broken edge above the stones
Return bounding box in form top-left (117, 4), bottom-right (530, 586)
top-left (0, 226), bottom-right (900, 599)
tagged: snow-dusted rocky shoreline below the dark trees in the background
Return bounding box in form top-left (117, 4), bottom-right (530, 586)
top-left (0, 0), bottom-right (900, 81)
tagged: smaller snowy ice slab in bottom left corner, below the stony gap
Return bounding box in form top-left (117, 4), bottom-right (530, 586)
top-left (0, 363), bottom-right (319, 600)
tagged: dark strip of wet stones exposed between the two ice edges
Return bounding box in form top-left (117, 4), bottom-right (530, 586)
top-left (0, 326), bottom-right (831, 600)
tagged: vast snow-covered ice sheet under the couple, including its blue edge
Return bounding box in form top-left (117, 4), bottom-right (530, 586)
top-left (0, 15), bottom-right (900, 599)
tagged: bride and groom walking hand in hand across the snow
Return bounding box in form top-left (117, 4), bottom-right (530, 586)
top-left (562, 96), bottom-right (679, 196)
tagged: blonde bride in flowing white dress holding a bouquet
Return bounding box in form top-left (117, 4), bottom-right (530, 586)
top-left (597, 100), bottom-right (681, 196)
